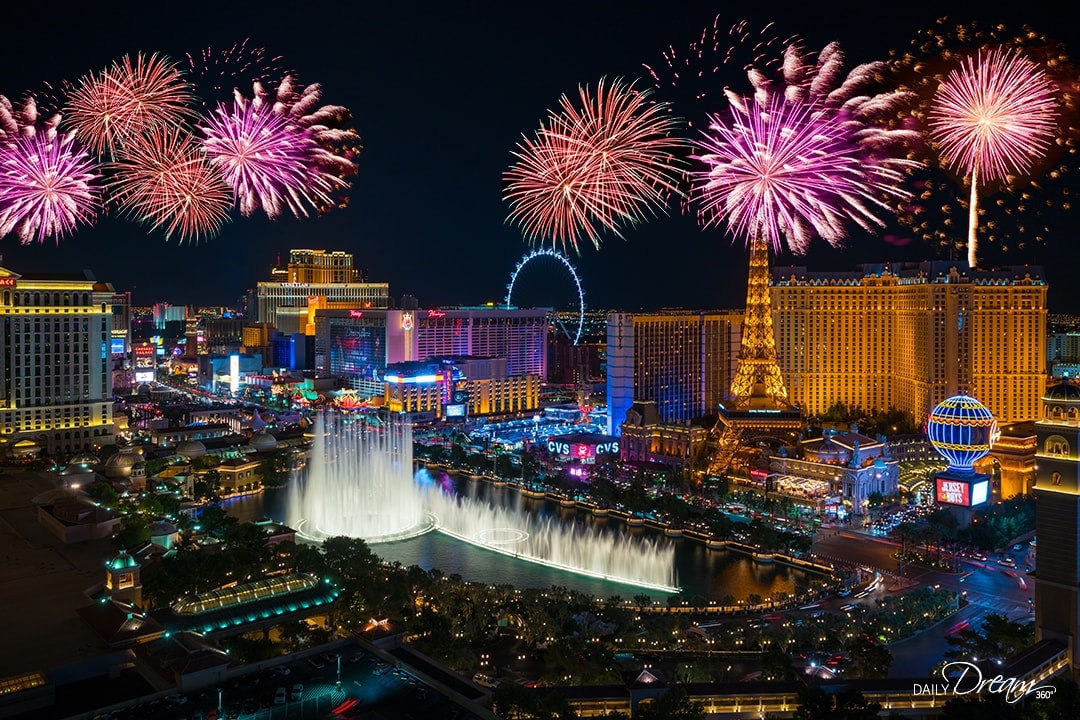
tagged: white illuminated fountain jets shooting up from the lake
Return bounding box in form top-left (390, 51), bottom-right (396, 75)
top-left (287, 412), bottom-right (679, 593)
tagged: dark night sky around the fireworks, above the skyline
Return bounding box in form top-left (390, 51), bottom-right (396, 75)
top-left (0, 0), bottom-right (1080, 312)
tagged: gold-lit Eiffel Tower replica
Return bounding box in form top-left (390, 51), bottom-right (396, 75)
top-left (708, 239), bottom-right (804, 475)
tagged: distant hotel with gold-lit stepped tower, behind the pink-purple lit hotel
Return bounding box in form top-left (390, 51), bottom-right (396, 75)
top-left (256, 249), bottom-right (390, 335)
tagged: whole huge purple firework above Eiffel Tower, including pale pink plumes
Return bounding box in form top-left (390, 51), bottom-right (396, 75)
top-left (692, 43), bottom-right (917, 254)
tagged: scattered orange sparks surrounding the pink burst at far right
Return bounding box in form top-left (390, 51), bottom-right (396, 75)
top-left (886, 17), bottom-right (1080, 259)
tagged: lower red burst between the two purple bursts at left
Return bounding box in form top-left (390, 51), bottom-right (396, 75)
top-left (109, 128), bottom-right (232, 242)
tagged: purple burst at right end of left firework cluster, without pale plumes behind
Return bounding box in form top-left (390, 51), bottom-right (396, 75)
top-left (202, 98), bottom-right (343, 218)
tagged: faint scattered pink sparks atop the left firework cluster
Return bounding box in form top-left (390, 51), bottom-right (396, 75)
top-left (187, 40), bottom-right (293, 106)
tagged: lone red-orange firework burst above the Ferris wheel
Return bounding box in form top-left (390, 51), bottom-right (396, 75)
top-left (503, 80), bottom-right (684, 254)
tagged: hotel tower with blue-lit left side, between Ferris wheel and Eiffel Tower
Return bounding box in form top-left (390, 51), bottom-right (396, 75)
top-left (606, 311), bottom-right (743, 435)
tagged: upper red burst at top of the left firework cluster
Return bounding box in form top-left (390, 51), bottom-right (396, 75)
top-left (66, 54), bottom-right (194, 154)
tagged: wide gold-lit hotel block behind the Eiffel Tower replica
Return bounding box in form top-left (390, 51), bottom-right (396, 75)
top-left (771, 260), bottom-right (1047, 423)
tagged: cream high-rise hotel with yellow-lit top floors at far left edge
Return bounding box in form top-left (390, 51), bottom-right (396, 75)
top-left (0, 268), bottom-right (117, 453)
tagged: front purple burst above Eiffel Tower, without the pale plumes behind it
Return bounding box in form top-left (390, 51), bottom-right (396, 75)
top-left (692, 97), bottom-right (904, 254)
